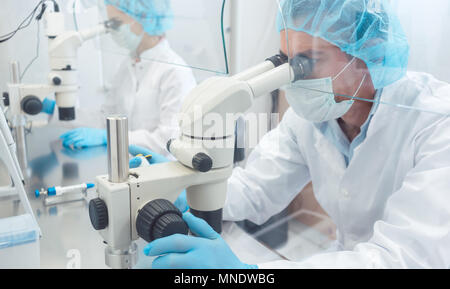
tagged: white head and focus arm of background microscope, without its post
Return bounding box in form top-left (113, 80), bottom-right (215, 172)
top-left (7, 11), bottom-right (120, 121)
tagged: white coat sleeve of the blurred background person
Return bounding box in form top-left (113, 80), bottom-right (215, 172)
top-left (129, 67), bottom-right (196, 158)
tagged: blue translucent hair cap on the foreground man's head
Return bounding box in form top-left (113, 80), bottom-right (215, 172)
top-left (277, 0), bottom-right (409, 89)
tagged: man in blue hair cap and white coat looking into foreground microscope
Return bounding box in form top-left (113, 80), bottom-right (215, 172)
top-left (137, 0), bottom-right (450, 269)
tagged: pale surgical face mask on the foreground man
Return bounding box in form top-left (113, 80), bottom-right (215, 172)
top-left (284, 58), bottom-right (366, 122)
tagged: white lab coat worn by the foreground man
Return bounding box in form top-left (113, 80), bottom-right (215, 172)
top-left (224, 73), bottom-right (450, 268)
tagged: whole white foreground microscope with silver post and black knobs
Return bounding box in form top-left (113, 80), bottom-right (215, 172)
top-left (89, 55), bottom-right (313, 268)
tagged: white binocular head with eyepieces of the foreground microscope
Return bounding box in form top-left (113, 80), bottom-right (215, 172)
top-left (167, 56), bottom-right (312, 170)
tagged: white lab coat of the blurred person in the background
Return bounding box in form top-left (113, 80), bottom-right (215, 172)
top-left (102, 39), bottom-right (196, 156)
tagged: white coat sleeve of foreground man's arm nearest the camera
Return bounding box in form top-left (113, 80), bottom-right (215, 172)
top-left (259, 119), bottom-right (450, 269)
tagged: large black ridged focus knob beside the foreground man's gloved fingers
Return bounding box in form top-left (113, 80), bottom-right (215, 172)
top-left (136, 199), bottom-right (188, 242)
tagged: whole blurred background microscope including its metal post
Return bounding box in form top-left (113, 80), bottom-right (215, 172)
top-left (3, 6), bottom-right (121, 169)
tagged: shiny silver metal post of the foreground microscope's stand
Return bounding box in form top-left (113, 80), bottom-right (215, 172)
top-left (106, 116), bottom-right (129, 183)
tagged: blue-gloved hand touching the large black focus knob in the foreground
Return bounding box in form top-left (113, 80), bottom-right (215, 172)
top-left (144, 213), bottom-right (258, 269)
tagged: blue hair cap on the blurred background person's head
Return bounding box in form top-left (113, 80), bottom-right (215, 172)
top-left (105, 0), bottom-right (173, 36)
